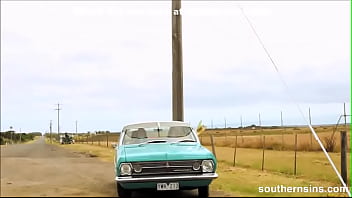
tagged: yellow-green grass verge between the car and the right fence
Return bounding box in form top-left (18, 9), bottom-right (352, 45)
top-left (211, 162), bottom-right (346, 197)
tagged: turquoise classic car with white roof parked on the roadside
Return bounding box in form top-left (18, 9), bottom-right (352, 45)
top-left (114, 121), bottom-right (218, 197)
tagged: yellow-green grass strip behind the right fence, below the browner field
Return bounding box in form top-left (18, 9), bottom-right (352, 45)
top-left (207, 147), bottom-right (350, 184)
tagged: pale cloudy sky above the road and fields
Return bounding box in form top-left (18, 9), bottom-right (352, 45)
top-left (1, 1), bottom-right (351, 132)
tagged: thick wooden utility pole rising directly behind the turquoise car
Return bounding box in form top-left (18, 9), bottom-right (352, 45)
top-left (171, 0), bottom-right (183, 121)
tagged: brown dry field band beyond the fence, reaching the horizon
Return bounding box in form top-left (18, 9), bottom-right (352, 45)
top-left (200, 125), bottom-right (350, 152)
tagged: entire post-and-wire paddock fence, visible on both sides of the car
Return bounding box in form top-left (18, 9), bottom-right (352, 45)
top-left (59, 126), bottom-right (350, 183)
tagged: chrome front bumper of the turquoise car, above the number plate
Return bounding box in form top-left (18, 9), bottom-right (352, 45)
top-left (115, 173), bottom-right (218, 184)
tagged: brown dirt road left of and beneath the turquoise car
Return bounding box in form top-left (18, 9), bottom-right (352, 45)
top-left (0, 138), bottom-right (223, 197)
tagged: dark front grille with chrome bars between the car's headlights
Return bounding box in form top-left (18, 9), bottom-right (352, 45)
top-left (132, 160), bottom-right (202, 176)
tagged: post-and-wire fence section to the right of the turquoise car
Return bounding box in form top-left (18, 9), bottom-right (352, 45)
top-left (200, 131), bottom-right (350, 183)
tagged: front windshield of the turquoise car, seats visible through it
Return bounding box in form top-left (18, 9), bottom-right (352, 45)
top-left (122, 126), bottom-right (197, 145)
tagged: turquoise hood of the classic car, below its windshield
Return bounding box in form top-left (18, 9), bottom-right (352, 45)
top-left (124, 143), bottom-right (214, 162)
